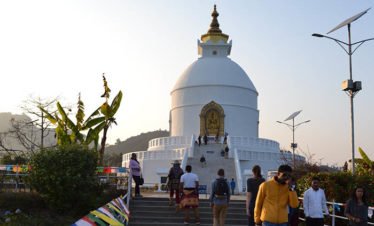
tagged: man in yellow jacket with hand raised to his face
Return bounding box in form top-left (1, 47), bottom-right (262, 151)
top-left (254, 165), bottom-right (299, 226)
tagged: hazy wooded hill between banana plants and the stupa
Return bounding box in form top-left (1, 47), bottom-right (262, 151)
top-left (105, 130), bottom-right (169, 155)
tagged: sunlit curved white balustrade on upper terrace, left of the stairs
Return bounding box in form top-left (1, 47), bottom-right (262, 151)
top-left (148, 136), bottom-right (191, 151)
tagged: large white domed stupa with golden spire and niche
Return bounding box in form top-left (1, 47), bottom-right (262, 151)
top-left (123, 6), bottom-right (303, 191)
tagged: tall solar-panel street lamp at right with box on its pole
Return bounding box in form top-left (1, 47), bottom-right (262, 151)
top-left (312, 8), bottom-right (374, 174)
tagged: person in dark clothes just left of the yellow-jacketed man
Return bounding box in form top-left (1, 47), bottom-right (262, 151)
top-left (245, 165), bottom-right (265, 226)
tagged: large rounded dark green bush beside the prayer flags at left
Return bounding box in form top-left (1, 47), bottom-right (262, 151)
top-left (28, 145), bottom-right (100, 212)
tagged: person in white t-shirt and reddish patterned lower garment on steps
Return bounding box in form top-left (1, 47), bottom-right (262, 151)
top-left (180, 165), bottom-right (200, 225)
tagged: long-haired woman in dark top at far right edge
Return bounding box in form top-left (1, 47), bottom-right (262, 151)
top-left (344, 186), bottom-right (369, 226)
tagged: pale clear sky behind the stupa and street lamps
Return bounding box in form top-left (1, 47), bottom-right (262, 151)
top-left (0, 0), bottom-right (374, 166)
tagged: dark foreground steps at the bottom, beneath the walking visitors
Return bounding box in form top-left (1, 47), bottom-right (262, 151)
top-left (129, 196), bottom-right (248, 226)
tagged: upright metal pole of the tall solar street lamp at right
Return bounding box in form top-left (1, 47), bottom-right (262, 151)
top-left (348, 24), bottom-right (355, 174)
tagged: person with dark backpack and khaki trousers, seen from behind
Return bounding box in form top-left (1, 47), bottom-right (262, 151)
top-left (209, 169), bottom-right (230, 226)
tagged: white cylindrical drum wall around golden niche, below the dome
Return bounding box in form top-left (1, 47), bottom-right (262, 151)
top-left (170, 86), bottom-right (259, 137)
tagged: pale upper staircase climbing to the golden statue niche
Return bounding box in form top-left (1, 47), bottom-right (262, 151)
top-left (187, 143), bottom-right (237, 193)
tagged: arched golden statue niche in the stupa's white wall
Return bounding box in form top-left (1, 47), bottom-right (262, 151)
top-left (200, 101), bottom-right (225, 137)
